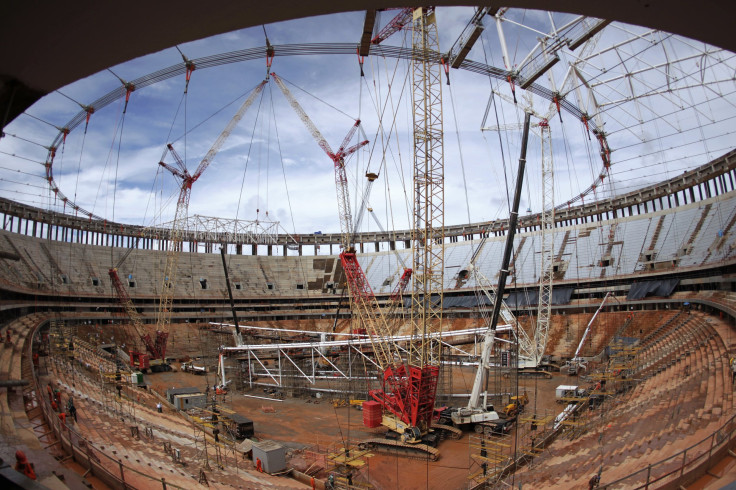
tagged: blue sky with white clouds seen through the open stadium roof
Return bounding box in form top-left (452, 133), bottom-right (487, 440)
top-left (0, 8), bottom-right (736, 239)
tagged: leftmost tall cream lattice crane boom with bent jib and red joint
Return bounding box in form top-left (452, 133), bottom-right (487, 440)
top-left (155, 80), bottom-right (267, 362)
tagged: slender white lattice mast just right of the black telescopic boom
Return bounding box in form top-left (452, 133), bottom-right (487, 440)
top-left (534, 121), bottom-right (555, 365)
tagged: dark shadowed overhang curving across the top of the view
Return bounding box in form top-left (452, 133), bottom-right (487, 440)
top-left (0, 0), bottom-right (736, 127)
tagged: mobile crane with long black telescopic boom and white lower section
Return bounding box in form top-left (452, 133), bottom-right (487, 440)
top-left (450, 113), bottom-right (530, 432)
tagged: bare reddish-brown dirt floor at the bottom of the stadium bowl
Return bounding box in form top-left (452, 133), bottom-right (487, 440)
top-left (139, 354), bottom-right (575, 489)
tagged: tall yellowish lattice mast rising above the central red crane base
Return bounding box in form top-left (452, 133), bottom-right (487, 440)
top-left (409, 7), bottom-right (445, 370)
